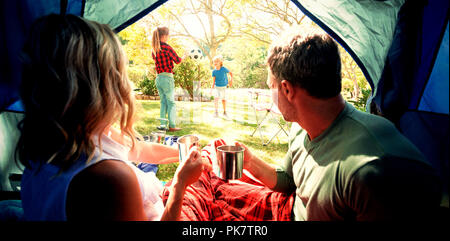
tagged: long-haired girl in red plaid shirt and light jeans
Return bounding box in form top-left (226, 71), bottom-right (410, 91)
top-left (152, 27), bottom-right (185, 131)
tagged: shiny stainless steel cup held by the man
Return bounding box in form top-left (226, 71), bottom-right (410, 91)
top-left (214, 145), bottom-right (245, 180)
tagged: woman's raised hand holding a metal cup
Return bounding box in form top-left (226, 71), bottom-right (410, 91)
top-left (174, 146), bottom-right (212, 188)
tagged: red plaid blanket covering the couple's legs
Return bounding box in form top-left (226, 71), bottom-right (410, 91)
top-left (162, 139), bottom-right (294, 221)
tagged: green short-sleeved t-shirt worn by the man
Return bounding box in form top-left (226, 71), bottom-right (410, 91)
top-left (274, 103), bottom-right (440, 220)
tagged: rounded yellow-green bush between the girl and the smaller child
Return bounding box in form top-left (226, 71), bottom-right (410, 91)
top-left (173, 58), bottom-right (209, 97)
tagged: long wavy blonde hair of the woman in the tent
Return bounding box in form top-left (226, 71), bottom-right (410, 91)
top-left (17, 14), bottom-right (139, 170)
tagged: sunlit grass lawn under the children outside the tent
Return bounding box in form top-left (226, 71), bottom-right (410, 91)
top-left (135, 97), bottom-right (288, 181)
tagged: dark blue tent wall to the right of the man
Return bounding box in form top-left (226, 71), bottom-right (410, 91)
top-left (373, 1), bottom-right (450, 198)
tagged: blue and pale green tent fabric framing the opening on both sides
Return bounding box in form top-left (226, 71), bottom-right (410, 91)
top-left (0, 0), bottom-right (450, 218)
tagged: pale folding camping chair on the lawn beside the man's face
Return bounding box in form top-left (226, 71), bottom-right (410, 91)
top-left (249, 90), bottom-right (289, 146)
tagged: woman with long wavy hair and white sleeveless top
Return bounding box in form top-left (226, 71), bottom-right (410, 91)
top-left (17, 14), bottom-right (209, 220)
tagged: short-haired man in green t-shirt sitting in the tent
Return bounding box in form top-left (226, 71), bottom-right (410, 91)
top-left (239, 26), bottom-right (441, 221)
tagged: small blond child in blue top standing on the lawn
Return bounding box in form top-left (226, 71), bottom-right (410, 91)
top-left (212, 55), bottom-right (233, 117)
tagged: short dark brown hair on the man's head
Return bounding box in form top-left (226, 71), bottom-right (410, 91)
top-left (267, 28), bottom-right (341, 99)
